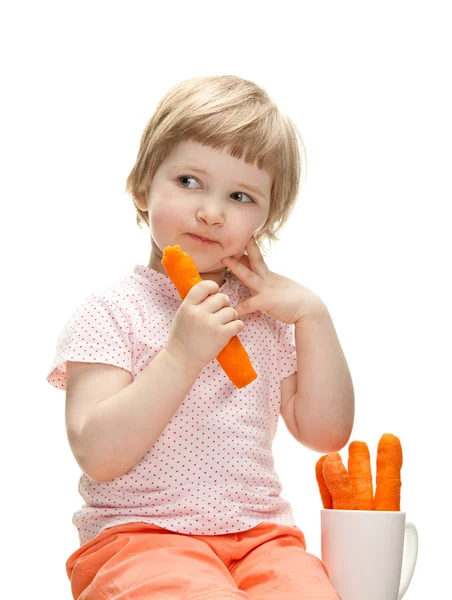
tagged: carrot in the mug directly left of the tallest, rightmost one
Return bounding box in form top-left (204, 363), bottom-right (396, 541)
top-left (348, 441), bottom-right (374, 510)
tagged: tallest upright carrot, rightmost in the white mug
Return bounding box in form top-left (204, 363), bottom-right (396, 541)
top-left (375, 433), bottom-right (403, 510)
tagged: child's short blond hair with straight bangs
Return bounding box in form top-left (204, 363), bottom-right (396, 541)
top-left (126, 75), bottom-right (306, 254)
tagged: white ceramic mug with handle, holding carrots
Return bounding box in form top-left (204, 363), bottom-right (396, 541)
top-left (320, 509), bottom-right (418, 600)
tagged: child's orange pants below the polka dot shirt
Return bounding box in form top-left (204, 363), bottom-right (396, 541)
top-left (66, 522), bottom-right (339, 600)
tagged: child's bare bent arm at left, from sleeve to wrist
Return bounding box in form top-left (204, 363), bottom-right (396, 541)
top-left (66, 348), bottom-right (202, 482)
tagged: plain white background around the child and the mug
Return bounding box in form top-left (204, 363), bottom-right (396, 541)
top-left (0, 0), bottom-right (452, 600)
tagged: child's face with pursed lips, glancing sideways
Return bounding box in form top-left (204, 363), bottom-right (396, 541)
top-left (139, 141), bottom-right (272, 285)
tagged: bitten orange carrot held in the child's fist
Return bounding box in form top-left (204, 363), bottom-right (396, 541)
top-left (162, 245), bottom-right (257, 388)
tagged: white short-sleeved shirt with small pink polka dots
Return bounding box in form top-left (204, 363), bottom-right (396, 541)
top-left (47, 265), bottom-right (297, 545)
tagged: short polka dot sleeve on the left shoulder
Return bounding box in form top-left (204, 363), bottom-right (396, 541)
top-left (47, 294), bottom-right (133, 390)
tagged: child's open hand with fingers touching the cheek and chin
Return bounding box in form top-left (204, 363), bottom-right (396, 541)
top-left (221, 236), bottom-right (324, 324)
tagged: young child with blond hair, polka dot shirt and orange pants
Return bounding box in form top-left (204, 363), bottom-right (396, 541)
top-left (47, 75), bottom-right (354, 600)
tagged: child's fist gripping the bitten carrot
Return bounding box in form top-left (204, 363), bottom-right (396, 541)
top-left (166, 279), bottom-right (244, 368)
